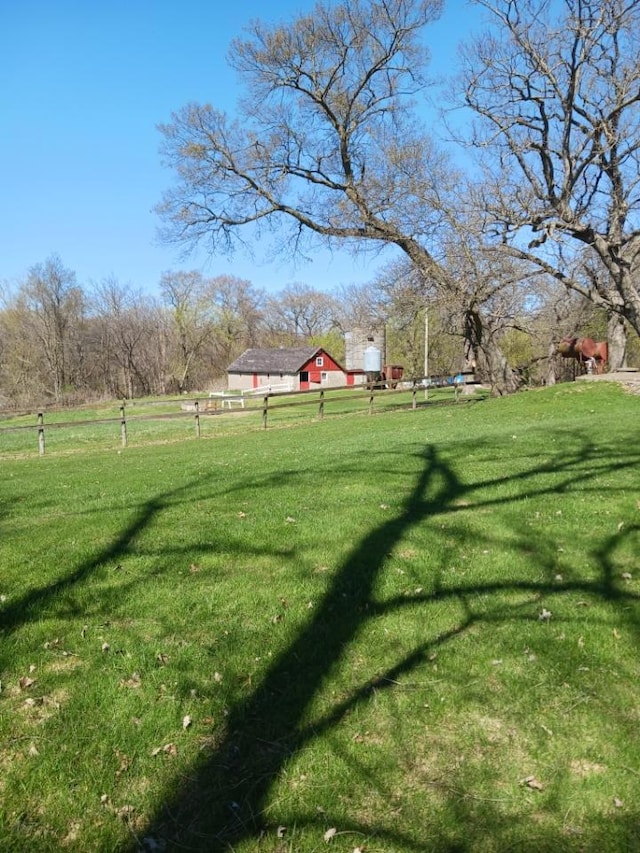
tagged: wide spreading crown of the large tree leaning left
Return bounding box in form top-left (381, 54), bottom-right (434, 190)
top-left (159, 0), bottom-right (512, 391)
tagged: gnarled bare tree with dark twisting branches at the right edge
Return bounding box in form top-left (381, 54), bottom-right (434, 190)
top-left (463, 0), bottom-right (640, 367)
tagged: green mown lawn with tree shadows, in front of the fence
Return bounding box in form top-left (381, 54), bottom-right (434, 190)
top-left (0, 383), bottom-right (640, 853)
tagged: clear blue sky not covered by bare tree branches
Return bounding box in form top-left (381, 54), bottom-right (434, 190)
top-left (0, 0), bottom-right (477, 292)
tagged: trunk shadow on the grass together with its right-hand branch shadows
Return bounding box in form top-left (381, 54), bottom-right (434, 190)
top-left (132, 441), bottom-right (637, 853)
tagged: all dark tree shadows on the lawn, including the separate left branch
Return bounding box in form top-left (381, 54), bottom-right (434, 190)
top-left (2, 430), bottom-right (638, 851)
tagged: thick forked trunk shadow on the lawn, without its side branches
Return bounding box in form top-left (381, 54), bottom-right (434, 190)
top-left (124, 448), bottom-right (450, 851)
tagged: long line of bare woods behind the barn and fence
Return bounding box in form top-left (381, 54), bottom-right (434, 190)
top-left (0, 246), bottom-right (632, 409)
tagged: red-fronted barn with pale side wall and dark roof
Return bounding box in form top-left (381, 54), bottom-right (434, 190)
top-left (227, 347), bottom-right (347, 391)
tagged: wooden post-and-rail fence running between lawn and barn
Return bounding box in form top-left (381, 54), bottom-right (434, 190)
top-left (0, 384), bottom-right (473, 456)
